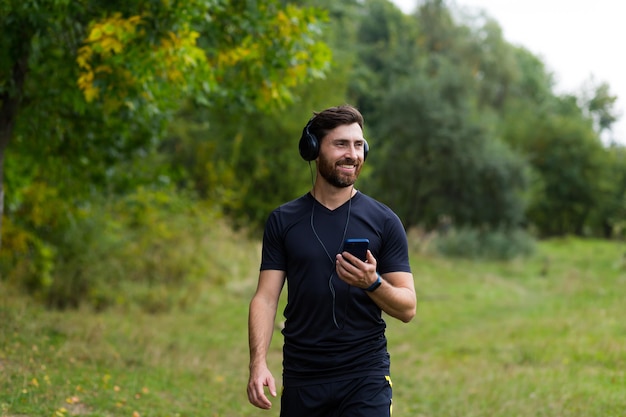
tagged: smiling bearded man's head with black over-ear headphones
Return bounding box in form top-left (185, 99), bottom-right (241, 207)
top-left (300, 105), bottom-right (368, 188)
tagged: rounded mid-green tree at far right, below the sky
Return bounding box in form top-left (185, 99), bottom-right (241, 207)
top-left (504, 97), bottom-right (609, 235)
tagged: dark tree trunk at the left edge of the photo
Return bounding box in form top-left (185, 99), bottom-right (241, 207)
top-left (0, 52), bottom-right (28, 248)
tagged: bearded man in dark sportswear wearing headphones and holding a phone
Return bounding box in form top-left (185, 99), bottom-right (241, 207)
top-left (248, 105), bottom-right (416, 417)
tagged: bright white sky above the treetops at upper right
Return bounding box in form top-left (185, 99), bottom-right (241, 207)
top-left (392, 0), bottom-right (626, 144)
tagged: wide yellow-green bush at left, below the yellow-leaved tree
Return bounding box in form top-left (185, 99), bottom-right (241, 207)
top-left (3, 188), bottom-right (258, 312)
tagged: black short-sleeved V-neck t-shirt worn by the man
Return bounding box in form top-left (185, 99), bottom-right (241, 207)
top-left (261, 192), bottom-right (411, 386)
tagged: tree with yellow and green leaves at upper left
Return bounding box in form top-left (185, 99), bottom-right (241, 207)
top-left (0, 0), bottom-right (330, 245)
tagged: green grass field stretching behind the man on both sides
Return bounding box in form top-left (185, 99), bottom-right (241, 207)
top-left (0, 239), bottom-right (626, 417)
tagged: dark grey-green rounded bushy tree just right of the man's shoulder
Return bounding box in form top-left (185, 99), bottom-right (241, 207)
top-left (373, 68), bottom-right (526, 231)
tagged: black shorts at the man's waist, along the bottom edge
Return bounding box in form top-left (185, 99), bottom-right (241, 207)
top-left (280, 376), bottom-right (391, 417)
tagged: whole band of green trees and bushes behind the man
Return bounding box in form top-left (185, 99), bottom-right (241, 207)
top-left (0, 0), bottom-right (626, 311)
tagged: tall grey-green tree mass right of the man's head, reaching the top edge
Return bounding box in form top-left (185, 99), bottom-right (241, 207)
top-left (352, 0), bottom-right (526, 227)
